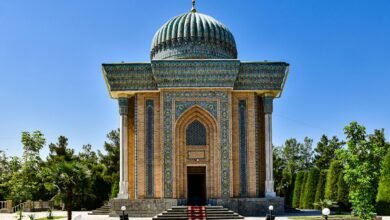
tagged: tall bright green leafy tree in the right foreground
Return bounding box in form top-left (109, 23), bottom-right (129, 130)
top-left (339, 122), bottom-right (388, 220)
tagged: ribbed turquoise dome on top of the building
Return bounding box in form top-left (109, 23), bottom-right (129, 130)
top-left (151, 12), bottom-right (237, 59)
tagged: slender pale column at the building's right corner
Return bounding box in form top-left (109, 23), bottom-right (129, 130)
top-left (263, 96), bottom-right (276, 198)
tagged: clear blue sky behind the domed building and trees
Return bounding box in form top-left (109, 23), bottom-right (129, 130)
top-left (0, 0), bottom-right (390, 158)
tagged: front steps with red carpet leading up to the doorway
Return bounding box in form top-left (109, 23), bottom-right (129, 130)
top-left (153, 206), bottom-right (244, 220)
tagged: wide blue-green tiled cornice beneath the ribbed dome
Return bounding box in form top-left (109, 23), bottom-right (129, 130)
top-left (103, 59), bottom-right (289, 98)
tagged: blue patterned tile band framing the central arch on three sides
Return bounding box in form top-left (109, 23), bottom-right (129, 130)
top-left (162, 91), bottom-right (231, 198)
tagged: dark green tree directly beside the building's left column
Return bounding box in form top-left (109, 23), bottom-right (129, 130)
top-left (98, 129), bottom-right (120, 198)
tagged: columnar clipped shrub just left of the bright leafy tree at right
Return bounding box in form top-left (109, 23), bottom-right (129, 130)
top-left (325, 160), bottom-right (342, 201)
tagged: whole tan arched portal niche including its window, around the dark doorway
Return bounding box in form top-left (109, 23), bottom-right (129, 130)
top-left (172, 105), bottom-right (221, 199)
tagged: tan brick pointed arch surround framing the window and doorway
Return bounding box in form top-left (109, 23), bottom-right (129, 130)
top-left (172, 105), bottom-right (221, 199)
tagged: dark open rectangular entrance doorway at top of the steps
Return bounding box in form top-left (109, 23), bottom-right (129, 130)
top-left (187, 167), bottom-right (206, 205)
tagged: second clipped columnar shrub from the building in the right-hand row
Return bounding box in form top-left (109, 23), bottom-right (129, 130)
top-left (303, 167), bottom-right (320, 209)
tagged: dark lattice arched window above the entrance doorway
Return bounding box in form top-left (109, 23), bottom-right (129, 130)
top-left (186, 120), bottom-right (206, 146)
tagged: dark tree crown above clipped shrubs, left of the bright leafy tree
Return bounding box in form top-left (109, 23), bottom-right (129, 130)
top-left (314, 135), bottom-right (345, 170)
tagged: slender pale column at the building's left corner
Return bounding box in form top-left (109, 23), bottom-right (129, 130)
top-left (118, 98), bottom-right (129, 199)
